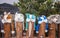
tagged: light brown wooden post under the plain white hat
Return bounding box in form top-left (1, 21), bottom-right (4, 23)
top-left (16, 22), bottom-right (23, 38)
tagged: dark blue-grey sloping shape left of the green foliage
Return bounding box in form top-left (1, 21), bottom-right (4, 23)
top-left (0, 3), bottom-right (19, 14)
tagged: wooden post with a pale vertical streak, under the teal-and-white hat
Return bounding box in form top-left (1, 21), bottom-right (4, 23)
top-left (26, 21), bottom-right (34, 38)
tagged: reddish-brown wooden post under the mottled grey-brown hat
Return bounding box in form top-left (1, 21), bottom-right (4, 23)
top-left (48, 23), bottom-right (56, 38)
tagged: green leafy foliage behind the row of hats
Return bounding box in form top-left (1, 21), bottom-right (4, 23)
top-left (14, 0), bottom-right (60, 16)
